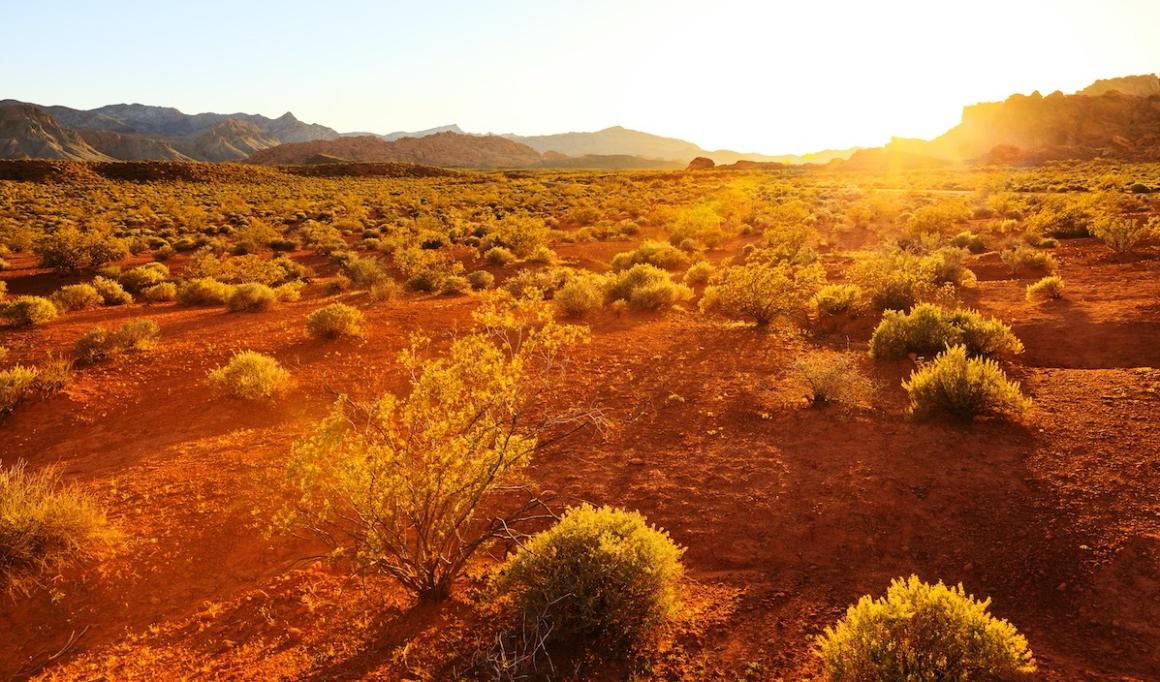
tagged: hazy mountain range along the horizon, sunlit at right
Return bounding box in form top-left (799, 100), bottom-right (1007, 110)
top-left (0, 74), bottom-right (1160, 168)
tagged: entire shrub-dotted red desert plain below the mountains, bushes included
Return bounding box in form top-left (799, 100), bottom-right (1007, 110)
top-left (0, 162), bottom-right (1160, 681)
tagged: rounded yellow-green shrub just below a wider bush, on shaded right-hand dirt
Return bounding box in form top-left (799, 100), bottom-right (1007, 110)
top-left (902, 346), bottom-right (1031, 420)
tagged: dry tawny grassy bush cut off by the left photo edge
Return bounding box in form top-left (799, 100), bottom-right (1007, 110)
top-left (0, 462), bottom-right (117, 594)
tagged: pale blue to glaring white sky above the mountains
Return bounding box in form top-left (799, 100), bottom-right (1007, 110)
top-left (0, 0), bottom-right (1160, 153)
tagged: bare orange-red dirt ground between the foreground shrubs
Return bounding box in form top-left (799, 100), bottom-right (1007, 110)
top-left (0, 233), bottom-right (1160, 681)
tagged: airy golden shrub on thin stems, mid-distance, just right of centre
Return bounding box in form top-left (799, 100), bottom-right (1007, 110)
top-left (701, 261), bottom-right (826, 326)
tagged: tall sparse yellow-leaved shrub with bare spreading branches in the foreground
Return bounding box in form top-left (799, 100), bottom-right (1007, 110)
top-left (284, 306), bottom-right (581, 600)
